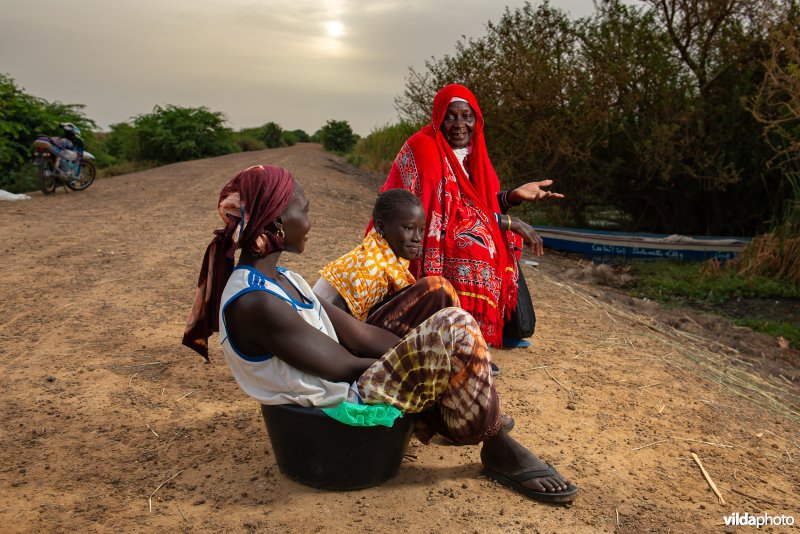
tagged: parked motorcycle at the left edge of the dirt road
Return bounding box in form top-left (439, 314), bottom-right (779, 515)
top-left (33, 135), bottom-right (97, 195)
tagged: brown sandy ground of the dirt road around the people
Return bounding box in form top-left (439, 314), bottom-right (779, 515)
top-left (0, 145), bottom-right (800, 532)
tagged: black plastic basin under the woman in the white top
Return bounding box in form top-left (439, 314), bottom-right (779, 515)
top-left (261, 404), bottom-right (414, 490)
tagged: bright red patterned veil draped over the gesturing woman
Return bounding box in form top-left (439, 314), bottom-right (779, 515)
top-left (381, 84), bottom-right (521, 347)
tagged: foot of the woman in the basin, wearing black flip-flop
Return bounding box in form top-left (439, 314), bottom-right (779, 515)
top-left (481, 429), bottom-right (570, 493)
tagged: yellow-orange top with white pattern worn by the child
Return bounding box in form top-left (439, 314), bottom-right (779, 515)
top-left (320, 228), bottom-right (416, 321)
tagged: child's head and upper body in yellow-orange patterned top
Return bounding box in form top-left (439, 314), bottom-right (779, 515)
top-left (314, 189), bottom-right (425, 321)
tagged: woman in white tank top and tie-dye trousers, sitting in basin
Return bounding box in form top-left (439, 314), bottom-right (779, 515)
top-left (183, 166), bottom-right (578, 502)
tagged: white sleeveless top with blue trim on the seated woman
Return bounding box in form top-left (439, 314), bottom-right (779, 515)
top-left (219, 266), bottom-right (350, 406)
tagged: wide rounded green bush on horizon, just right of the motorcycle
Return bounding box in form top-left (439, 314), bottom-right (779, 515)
top-left (133, 105), bottom-right (239, 163)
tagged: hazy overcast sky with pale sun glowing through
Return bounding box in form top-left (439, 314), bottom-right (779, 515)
top-left (0, 0), bottom-right (608, 135)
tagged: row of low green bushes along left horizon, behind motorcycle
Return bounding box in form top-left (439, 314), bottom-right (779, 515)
top-left (0, 73), bottom-right (358, 193)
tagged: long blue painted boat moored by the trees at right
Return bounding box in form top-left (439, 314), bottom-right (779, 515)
top-left (534, 226), bottom-right (750, 261)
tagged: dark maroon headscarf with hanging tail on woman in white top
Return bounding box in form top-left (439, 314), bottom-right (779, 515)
top-left (183, 165), bottom-right (294, 361)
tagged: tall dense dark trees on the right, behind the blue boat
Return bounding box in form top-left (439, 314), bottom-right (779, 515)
top-left (395, 0), bottom-right (800, 239)
